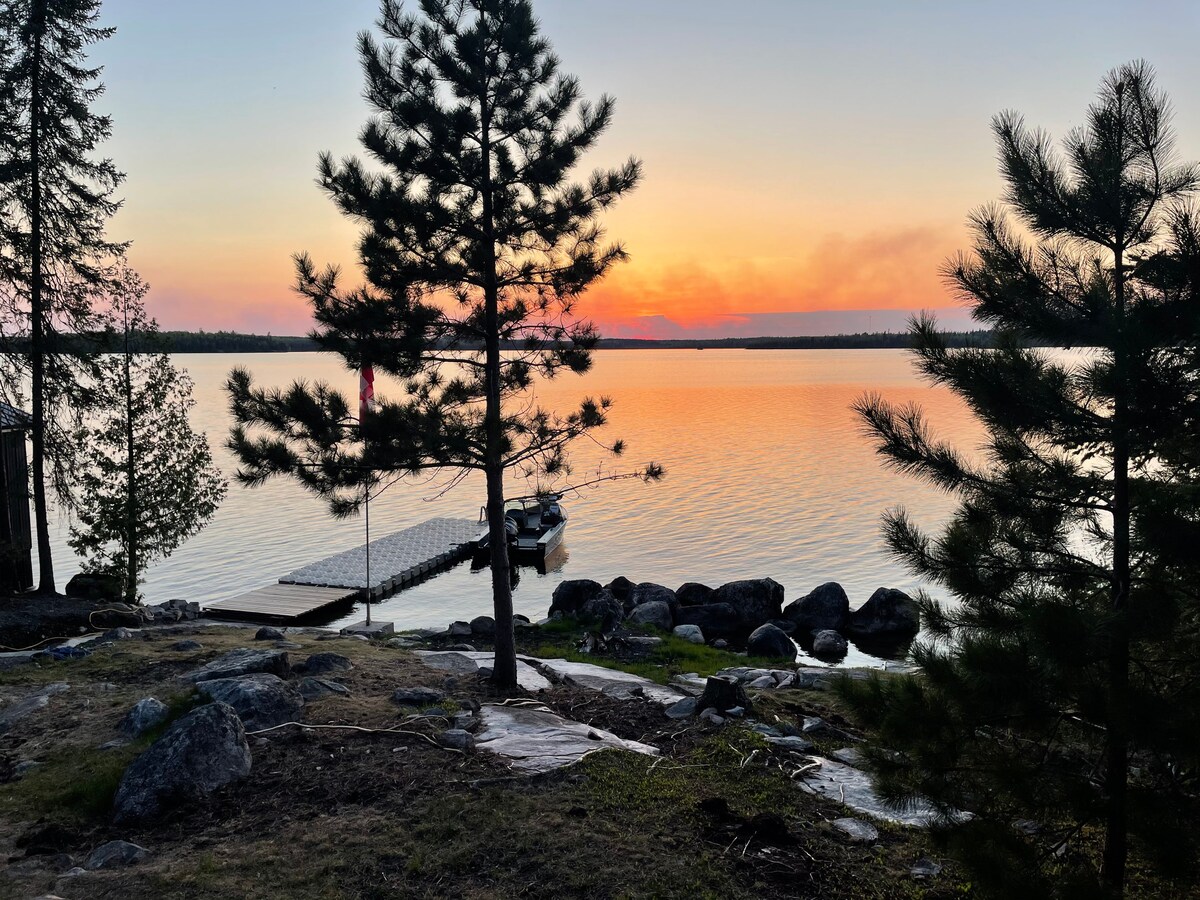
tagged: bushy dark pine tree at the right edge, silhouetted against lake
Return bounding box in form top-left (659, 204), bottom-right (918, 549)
top-left (846, 62), bottom-right (1200, 896)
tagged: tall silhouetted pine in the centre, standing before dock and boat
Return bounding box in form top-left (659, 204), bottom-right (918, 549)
top-left (229, 0), bottom-right (659, 685)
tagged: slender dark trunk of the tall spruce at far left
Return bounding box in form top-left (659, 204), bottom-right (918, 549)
top-left (29, 0), bottom-right (55, 594)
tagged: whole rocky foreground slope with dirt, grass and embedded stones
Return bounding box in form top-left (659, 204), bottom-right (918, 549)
top-left (0, 624), bottom-right (979, 900)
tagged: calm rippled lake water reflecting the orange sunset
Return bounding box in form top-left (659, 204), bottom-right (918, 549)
top-left (37, 350), bottom-right (982, 662)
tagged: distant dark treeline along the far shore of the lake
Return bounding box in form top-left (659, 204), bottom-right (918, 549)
top-left (6, 331), bottom-right (991, 353)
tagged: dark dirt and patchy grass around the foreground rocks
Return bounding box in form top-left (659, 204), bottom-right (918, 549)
top-left (0, 626), bottom-right (1132, 900)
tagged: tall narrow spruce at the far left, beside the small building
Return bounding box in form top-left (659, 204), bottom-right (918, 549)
top-left (0, 0), bottom-right (124, 593)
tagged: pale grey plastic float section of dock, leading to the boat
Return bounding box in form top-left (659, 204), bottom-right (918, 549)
top-left (280, 518), bottom-right (480, 596)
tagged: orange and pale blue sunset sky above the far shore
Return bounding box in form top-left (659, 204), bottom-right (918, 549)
top-left (92, 0), bottom-right (1200, 337)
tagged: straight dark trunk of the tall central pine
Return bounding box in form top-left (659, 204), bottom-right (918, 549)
top-left (479, 31), bottom-right (517, 688)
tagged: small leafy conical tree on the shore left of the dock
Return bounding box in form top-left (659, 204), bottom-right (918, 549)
top-left (68, 272), bottom-right (226, 604)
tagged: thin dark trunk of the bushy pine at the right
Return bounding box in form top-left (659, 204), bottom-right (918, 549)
top-left (1102, 238), bottom-right (1130, 896)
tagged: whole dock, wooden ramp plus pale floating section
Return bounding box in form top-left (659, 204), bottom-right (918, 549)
top-left (204, 518), bottom-right (480, 622)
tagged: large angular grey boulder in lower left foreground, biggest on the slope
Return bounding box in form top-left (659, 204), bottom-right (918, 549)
top-left (114, 703), bottom-right (251, 822)
